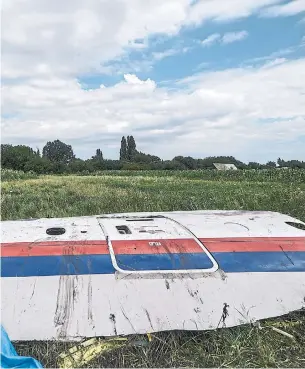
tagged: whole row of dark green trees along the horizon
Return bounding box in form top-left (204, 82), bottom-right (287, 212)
top-left (1, 136), bottom-right (305, 174)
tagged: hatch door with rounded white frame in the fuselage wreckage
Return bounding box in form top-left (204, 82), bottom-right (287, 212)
top-left (98, 216), bottom-right (218, 274)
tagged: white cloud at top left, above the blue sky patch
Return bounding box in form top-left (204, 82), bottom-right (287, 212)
top-left (2, 0), bottom-right (281, 78)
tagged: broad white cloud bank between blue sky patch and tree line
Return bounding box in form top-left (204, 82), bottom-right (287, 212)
top-left (2, 59), bottom-right (305, 160)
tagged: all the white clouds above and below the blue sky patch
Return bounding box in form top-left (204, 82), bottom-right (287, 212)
top-left (1, 0), bottom-right (305, 158)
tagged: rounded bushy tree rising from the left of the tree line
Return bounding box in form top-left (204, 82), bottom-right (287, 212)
top-left (42, 140), bottom-right (75, 163)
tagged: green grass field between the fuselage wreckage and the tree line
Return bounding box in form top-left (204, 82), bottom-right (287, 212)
top-left (1, 174), bottom-right (305, 220)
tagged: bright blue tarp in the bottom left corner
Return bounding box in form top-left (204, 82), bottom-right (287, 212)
top-left (1, 325), bottom-right (43, 368)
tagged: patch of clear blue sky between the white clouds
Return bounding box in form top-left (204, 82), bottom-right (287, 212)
top-left (79, 14), bottom-right (305, 88)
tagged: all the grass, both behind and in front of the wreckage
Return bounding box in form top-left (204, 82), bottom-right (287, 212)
top-left (1, 170), bottom-right (305, 367)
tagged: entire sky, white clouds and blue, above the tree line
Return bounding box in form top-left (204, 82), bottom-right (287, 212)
top-left (1, 0), bottom-right (305, 161)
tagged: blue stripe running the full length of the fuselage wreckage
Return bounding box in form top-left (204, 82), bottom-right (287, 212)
top-left (1, 251), bottom-right (305, 277)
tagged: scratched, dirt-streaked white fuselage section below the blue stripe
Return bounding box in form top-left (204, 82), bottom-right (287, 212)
top-left (2, 273), bottom-right (305, 340)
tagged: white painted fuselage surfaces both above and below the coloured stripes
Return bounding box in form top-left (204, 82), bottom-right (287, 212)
top-left (1, 211), bottom-right (305, 340)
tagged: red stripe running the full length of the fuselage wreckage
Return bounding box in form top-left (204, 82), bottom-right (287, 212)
top-left (1, 237), bottom-right (305, 257)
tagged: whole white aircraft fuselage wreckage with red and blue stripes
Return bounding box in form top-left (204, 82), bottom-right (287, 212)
top-left (1, 211), bottom-right (305, 340)
